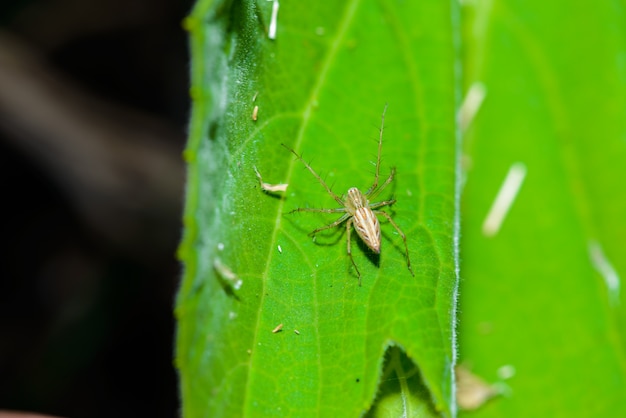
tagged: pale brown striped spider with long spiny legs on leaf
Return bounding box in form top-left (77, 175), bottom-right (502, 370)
top-left (282, 105), bottom-right (414, 286)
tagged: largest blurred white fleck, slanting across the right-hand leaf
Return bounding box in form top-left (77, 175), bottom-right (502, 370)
top-left (483, 163), bottom-right (526, 237)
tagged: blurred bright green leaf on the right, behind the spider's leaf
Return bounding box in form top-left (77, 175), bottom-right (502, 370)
top-left (460, 0), bottom-right (626, 417)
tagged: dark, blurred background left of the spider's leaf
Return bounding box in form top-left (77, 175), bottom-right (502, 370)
top-left (0, 0), bottom-right (191, 417)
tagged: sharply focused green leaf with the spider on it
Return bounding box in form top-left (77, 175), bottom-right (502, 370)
top-left (176, 0), bottom-right (458, 417)
